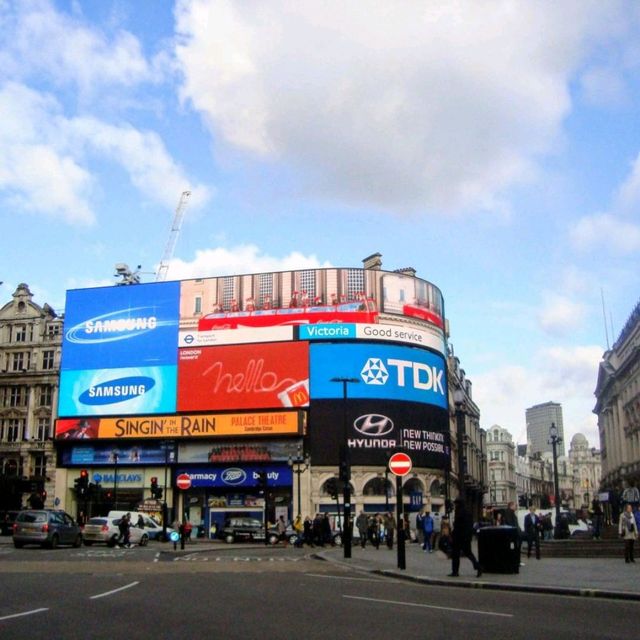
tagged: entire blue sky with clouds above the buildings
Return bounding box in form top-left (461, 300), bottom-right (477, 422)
top-left (0, 0), bottom-right (640, 448)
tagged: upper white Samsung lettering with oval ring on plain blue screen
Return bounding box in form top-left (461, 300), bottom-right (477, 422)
top-left (65, 307), bottom-right (175, 344)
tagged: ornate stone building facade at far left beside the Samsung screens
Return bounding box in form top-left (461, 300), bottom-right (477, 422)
top-left (0, 283), bottom-right (63, 509)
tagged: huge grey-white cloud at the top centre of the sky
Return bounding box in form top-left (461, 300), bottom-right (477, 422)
top-left (176, 0), bottom-right (617, 211)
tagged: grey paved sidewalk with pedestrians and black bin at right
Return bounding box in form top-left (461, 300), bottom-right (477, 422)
top-left (315, 543), bottom-right (640, 601)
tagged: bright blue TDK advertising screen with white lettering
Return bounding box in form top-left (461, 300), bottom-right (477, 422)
top-left (310, 343), bottom-right (448, 408)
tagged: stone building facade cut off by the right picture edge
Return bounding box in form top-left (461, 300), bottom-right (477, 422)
top-left (593, 302), bottom-right (640, 501)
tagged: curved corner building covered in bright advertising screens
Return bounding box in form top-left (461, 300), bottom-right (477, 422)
top-left (56, 254), bottom-right (451, 535)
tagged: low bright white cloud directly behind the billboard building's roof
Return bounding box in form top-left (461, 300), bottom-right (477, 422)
top-left (161, 245), bottom-right (331, 280)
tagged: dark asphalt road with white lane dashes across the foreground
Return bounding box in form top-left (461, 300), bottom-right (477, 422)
top-left (0, 544), bottom-right (640, 640)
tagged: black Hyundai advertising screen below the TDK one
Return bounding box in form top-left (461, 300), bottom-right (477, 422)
top-left (309, 400), bottom-right (451, 469)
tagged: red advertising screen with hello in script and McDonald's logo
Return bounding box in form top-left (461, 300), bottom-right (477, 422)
top-left (178, 342), bottom-right (309, 411)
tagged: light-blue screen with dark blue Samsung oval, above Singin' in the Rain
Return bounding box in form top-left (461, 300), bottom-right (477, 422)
top-left (58, 365), bottom-right (177, 417)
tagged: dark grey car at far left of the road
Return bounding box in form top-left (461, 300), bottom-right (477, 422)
top-left (13, 509), bottom-right (82, 549)
